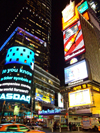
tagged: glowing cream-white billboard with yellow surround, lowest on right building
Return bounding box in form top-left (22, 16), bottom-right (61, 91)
top-left (68, 88), bottom-right (92, 107)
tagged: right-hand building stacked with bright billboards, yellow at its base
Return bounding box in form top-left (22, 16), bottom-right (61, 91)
top-left (60, 1), bottom-right (100, 129)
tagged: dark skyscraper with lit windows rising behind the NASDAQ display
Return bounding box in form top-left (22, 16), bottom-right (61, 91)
top-left (0, 0), bottom-right (51, 71)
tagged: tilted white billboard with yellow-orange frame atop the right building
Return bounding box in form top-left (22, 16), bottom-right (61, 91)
top-left (62, 1), bottom-right (79, 30)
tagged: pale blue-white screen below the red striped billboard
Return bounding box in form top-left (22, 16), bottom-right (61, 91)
top-left (64, 60), bottom-right (88, 84)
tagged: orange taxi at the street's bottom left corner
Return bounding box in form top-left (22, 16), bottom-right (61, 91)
top-left (0, 123), bottom-right (45, 133)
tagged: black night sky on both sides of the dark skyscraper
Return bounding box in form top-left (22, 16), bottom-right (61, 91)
top-left (0, 0), bottom-right (80, 80)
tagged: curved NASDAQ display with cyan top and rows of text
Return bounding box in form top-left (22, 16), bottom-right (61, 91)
top-left (0, 46), bottom-right (34, 103)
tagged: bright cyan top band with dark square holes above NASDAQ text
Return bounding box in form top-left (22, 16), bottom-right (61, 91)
top-left (5, 46), bottom-right (34, 69)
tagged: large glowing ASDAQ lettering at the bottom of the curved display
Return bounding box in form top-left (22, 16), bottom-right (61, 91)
top-left (0, 93), bottom-right (30, 103)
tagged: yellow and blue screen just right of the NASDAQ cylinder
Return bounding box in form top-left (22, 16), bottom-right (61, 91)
top-left (35, 88), bottom-right (55, 104)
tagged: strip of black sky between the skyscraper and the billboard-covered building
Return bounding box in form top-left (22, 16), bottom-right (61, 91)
top-left (51, 0), bottom-right (80, 80)
